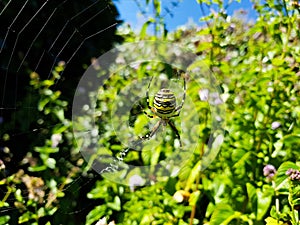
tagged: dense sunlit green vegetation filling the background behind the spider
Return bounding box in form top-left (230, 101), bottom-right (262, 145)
top-left (0, 1), bottom-right (300, 225)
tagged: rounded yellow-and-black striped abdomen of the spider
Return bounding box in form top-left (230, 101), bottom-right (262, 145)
top-left (153, 89), bottom-right (176, 117)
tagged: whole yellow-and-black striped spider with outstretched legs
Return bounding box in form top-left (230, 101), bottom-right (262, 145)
top-left (141, 74), bottom-right (186, 147)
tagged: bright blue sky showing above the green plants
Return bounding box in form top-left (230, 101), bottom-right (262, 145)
top-left (114, 0), bottom-right (256, 31)
